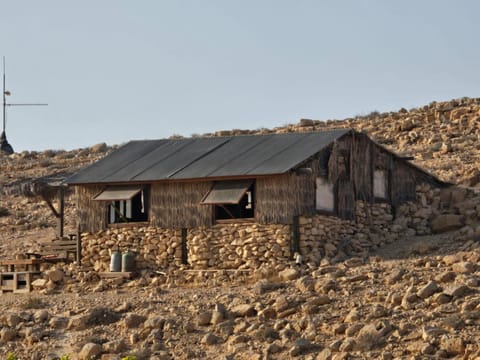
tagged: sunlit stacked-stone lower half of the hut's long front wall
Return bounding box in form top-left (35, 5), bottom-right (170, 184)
top-left (82, 224), bottom-right (290, 271)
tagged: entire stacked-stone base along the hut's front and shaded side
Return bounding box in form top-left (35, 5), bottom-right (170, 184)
top-left (79, 184), bottom-right (480, 271)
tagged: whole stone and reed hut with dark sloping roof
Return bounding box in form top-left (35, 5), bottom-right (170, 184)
top-left (67, 129), bottom-right (447, 270)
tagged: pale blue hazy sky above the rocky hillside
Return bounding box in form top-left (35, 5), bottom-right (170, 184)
top-left (0, 0), bottom-right (480, 151)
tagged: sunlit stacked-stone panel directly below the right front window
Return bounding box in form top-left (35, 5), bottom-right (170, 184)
top-left (187, 224), bottom-right (290, 269)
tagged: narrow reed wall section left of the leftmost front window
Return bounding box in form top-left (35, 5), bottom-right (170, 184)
top-left (75, 185), bottom-right (107, 232)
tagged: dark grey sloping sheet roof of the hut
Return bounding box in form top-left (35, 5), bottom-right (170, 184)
top-left (66, 129), bottom-right (351, 184)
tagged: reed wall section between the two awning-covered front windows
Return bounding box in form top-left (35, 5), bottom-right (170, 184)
top-left (150, 181), bottom-right (213, 228)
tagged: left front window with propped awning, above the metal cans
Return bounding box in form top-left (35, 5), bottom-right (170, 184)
top-left (93, 185), bottom-right (148, 224)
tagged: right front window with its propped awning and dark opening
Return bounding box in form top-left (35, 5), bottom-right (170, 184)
top-left (201, 180), bottom-right (255, 220)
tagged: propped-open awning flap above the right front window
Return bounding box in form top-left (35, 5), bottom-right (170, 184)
top-left (201, 180), bottom-right (253, 205)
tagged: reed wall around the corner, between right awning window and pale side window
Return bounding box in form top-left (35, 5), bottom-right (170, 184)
top-left (256, 173), bottom-right (315, 224)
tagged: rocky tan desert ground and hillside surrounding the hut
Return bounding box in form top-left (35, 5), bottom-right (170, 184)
top-left (0, 98), bottom-right (480, 359)
